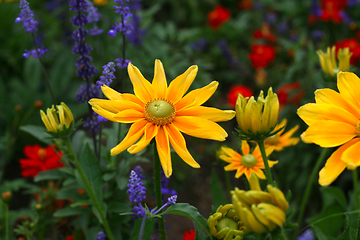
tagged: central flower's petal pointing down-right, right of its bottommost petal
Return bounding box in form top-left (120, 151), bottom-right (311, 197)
top-left (164, 124), bottom-right (200, 168)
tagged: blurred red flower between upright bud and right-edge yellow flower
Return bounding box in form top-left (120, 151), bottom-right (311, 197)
top-left (277, 82), bottom-right (305, 108)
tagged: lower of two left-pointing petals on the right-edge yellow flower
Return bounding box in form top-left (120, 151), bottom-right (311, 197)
top-left (301, 120), bottom-right (357, 147)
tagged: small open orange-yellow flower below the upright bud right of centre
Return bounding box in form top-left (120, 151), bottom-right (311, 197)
top-left (219, 140), bottom-right (278, 179)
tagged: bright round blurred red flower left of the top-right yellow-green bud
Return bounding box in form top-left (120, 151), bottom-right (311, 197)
top-left (249, 44), bottom-right (275, 68)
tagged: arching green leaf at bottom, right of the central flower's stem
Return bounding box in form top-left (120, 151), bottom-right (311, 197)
top-left (161, 203), bottom-right (210, 238)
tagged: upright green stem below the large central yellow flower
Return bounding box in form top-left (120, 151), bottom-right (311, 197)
top-left (153, 142), bottom-right (166, 240)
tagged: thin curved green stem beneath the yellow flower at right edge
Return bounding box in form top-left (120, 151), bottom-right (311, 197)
top-left (293, 148), bottom-right (328, 240)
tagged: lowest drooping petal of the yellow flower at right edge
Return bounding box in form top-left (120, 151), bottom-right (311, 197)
top-left (319, 142), bottom-right (352, 186)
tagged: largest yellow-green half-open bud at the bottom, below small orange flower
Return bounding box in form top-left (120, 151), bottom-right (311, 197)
top-left (231, 174), bottom-right (289, 233)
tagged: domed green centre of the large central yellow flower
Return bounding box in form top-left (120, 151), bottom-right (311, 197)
top-left (144, 99), bottom-right (176, 125)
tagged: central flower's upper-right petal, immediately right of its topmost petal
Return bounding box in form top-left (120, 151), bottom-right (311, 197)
top-left (166, 65), bottom-right (198, 104)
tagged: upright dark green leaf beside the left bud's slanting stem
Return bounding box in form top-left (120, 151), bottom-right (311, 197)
top-left (77, 144), bottom-right (106, 222)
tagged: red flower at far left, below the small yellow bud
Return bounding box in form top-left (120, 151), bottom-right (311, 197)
top-left (20, 145), bottom-right (64, 177)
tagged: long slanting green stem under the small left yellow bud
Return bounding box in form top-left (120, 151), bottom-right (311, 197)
top-left (64, 138), bottom-right (114, 240)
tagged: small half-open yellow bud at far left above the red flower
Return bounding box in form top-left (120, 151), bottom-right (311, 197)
top-left (40, 102), bottom-right (74, 133)
